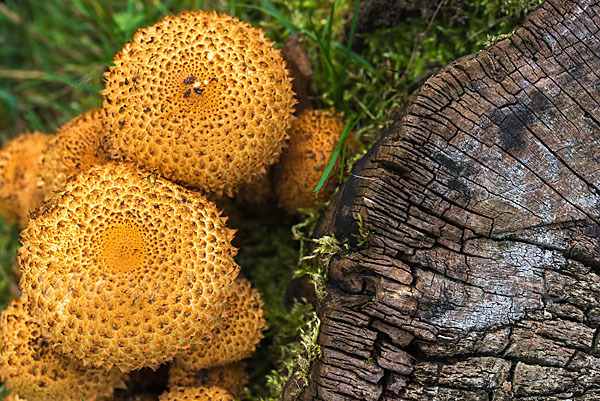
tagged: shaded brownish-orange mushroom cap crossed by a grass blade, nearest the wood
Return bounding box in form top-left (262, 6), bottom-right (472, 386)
top-left (274, 109), bottom-right (345, 214)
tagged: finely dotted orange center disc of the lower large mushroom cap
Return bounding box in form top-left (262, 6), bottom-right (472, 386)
top-left (98, 223), bottom-right (148, 272)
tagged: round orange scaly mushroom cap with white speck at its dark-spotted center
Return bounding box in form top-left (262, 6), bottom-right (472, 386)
top-left (102, 11), bottom-right (295, 195)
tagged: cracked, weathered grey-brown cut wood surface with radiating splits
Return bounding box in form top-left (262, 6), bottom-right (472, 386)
top-left (284, 0), bottom-right (600, 401)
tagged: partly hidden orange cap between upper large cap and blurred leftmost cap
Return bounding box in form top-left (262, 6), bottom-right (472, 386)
top-left (38, 108), bottom-right (107, 199)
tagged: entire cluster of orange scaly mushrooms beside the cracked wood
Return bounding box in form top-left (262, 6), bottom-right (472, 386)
top-left (0, 11), bottom-right (343, 401)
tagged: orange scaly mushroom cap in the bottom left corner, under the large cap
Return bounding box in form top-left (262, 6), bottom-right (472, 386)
top-left (0, 297), bottom-right (125, 401)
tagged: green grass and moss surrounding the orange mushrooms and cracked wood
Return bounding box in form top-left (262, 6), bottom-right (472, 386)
top-left (0, 0), bottom-right (539, 399)
